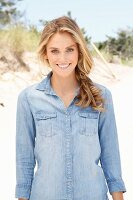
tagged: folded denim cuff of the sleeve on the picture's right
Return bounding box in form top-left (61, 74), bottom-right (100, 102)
top-left (108, 179), bottom-right (126, 194)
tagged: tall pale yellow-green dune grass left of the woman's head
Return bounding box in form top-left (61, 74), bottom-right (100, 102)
top-left (0, 24), bottom-right (40, 55)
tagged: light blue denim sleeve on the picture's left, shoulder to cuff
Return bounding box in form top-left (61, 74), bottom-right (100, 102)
top-left (15, 90), bottom-right (35, 199)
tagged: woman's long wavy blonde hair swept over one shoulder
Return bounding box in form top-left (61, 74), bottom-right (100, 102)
top-left (38, 16), bottom-right (104, 111)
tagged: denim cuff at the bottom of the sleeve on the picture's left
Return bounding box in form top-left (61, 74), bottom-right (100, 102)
top-left (15, 184), bottom-right (31, 199)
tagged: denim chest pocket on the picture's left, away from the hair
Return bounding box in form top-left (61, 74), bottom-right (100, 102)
top-left (35, 112), bottom-right (57, 137)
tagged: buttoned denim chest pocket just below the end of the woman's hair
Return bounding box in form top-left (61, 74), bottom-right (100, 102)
top-left (79, 112), bottom-right (98, 136)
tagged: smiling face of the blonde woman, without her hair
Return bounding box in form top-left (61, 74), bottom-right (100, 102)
top-left (45, 32), bottom-right (79, 77)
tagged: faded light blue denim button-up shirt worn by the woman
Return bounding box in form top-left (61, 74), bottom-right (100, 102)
top-left (16, 73), bottom-right (125, 200)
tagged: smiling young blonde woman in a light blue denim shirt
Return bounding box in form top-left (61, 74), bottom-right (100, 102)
top-left (16, 17), bottom-right (125, 200)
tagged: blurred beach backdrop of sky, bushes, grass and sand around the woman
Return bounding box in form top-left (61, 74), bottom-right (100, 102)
top-left (0, 0), bottom-right (133, 200)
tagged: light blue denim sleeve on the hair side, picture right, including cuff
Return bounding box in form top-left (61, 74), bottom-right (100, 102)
top-left (99, 89), bottom-right (126, 193)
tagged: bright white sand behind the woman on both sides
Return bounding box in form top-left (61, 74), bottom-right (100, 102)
top-left (0, 57), bottom-right (133, 200)
